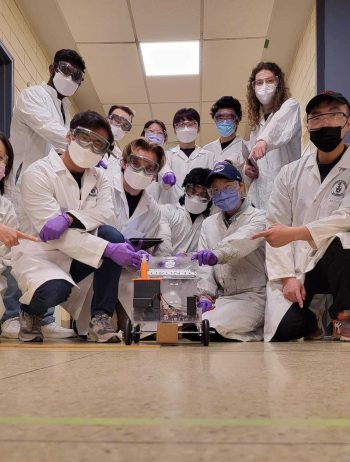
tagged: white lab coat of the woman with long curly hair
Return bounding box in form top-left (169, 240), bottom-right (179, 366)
top-left (248, 98), bottom-right (301, 210)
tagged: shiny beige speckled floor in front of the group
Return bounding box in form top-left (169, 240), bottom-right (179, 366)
top-left (0, 341), bottom-right (350, 462)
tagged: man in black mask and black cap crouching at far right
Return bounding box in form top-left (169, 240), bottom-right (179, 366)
top-left (255, 92), bottom-right (350, 341)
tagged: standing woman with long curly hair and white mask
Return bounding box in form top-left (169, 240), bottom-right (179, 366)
top-left (245, 62), bottom-right (301, 210)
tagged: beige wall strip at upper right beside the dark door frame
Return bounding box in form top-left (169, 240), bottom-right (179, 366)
top-left (287, 7), bottom-right (316, 152)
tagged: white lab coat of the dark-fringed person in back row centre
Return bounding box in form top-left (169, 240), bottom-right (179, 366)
top-left (149, 145), bottom-right (215, 204)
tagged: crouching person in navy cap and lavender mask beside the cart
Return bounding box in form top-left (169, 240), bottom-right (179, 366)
top-left (191, 161), bottom-right (266, 341)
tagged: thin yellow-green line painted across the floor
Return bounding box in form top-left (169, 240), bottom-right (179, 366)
top-left (0, 416), bottom-right (350, 429)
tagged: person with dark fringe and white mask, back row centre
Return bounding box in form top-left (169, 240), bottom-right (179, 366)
top-left (154, 108), bottom-right (215, 204)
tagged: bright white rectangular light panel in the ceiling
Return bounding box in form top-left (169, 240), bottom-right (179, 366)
top-left (140, 40), bottom-right (199, 76)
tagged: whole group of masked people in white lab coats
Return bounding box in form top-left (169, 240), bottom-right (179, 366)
top-left (0, 49), bottom-right (350, 342)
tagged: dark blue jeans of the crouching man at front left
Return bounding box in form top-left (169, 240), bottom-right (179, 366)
top-left (21, 225), bottom-right (124, 316)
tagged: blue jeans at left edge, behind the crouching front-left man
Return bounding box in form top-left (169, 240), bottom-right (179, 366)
top-left (0, 266), bottom-right (55, 325)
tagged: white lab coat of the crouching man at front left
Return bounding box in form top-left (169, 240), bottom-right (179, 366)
top-left (12, 149), bottom-right (115, 318)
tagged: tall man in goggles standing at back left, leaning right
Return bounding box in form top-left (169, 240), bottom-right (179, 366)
top-left (2, 49), bottom-right (85, 338)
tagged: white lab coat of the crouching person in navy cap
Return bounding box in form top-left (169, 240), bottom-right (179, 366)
top-left (198, 203), bottom-right (266, 341)
